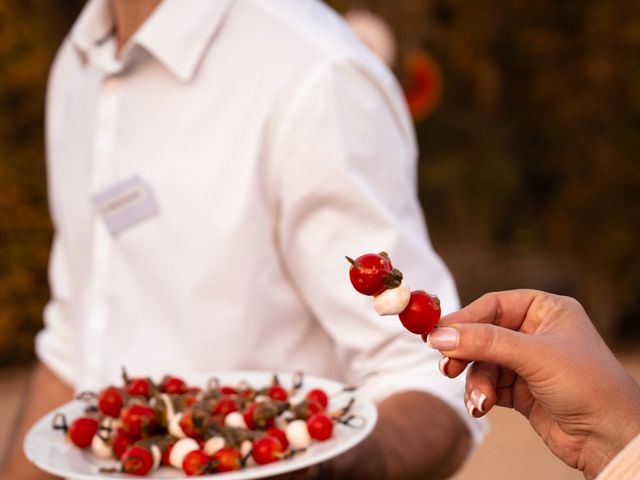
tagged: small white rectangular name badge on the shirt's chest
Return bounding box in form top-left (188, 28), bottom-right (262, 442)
top-left (91, 176), bottom-right (158, 235)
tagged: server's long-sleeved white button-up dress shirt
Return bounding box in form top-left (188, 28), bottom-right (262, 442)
top-left (37, 0), bottom-right (482, 438)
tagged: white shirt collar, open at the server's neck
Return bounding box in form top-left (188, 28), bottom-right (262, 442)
top-left (70, 0), bottom-right (233, 81)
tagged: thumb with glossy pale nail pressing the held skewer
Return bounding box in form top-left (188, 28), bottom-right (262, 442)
top-left (427, 323), bottom-right (543, 374)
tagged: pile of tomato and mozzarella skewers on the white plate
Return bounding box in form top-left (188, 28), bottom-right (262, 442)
top-left (53, 370), bottom-right (361, 476)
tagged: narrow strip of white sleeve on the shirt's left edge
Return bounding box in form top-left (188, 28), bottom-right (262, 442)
top-left (35, 237), bottom-right (77, 386)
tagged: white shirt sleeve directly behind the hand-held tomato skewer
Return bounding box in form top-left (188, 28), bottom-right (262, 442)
top-left (270, 58), bottom-right (485, 441)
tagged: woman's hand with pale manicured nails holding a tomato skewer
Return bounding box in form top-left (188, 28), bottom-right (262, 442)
top-left (426, 290), bottom-right (640, 478)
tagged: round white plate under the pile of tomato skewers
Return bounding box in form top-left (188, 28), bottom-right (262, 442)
top-left (24, 371), bottom-right (378, 480)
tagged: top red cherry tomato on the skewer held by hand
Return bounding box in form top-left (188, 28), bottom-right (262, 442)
top-left (347, 252), bottom-right (402, 295)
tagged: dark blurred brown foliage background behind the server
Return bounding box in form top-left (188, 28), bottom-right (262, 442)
top-left (0, 0), bottom-right (640, 365)
